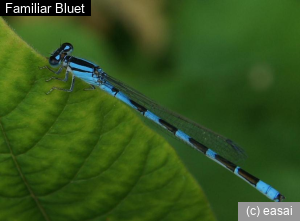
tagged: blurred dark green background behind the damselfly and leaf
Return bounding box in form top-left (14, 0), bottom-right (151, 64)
top-left (5, 0), bottom-right (300, 221)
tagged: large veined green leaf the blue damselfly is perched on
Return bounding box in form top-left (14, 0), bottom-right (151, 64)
top-left (0, 18), bottom-right (214, 221)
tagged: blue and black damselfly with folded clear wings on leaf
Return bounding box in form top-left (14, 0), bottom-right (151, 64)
top-left (41, 43), bottom-right (285, 202)
